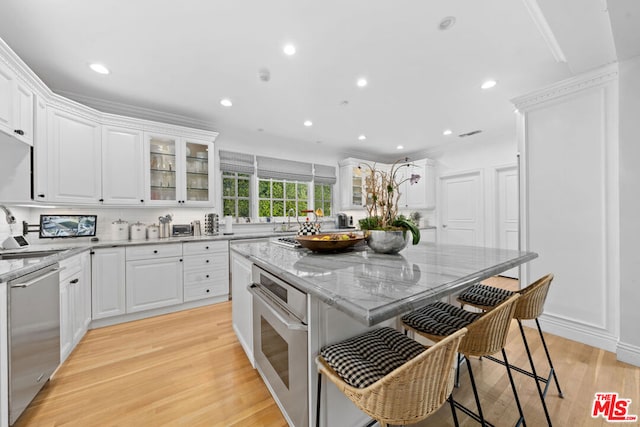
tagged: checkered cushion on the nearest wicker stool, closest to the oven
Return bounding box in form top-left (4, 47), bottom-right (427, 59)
top-left (320, 328), bottom-right (426, 388)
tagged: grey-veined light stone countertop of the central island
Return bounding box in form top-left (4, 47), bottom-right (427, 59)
top-left (231, 242), bottom-right (538, 325)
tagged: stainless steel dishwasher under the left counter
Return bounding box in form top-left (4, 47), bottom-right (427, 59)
top-left (8, 264), bottom-right (60, 424)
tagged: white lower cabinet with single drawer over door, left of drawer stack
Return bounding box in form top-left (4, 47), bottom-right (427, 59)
top-left (126, 244), bottom-right (183, 313)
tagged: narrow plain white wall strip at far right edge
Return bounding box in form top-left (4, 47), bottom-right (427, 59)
top-left (617, 57), bottom-right (640, 366)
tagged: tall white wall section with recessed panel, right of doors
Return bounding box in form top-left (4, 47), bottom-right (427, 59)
top-left (515, 66), bottom-right (620, 358)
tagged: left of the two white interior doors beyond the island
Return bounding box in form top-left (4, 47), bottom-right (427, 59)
top-left (438, 171), bottom-right (485, 246)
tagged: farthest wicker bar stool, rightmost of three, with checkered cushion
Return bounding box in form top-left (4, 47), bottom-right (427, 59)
top-left (458, 274), bottom-right (564, 426)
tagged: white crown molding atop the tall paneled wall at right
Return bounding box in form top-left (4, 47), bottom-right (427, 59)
top-left (511, 63), bottom-right (618, 111)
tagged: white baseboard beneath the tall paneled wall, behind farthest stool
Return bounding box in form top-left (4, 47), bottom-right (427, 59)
top-left (527, 314), bottom-right (618, 353)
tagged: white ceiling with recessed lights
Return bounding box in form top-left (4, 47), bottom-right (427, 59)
top-left (0, 0), bottom-right (636, 157)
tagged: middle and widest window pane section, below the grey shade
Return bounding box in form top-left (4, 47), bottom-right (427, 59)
top-left (258, 179), bottom-right (309, 217)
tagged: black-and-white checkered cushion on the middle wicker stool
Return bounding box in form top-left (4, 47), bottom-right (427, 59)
top-left (402, 301), bottom-right (480, 336)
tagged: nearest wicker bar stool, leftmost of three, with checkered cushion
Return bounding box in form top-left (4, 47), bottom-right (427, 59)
top-left (316, 327), bottom-right (467, 427)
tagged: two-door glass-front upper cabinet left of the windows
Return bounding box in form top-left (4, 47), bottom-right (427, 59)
top-left (145, 133), bottom-right (213, 206)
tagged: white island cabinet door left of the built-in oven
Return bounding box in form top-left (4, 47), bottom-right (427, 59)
top-left (231, 252), bottom-right (254, 365)
